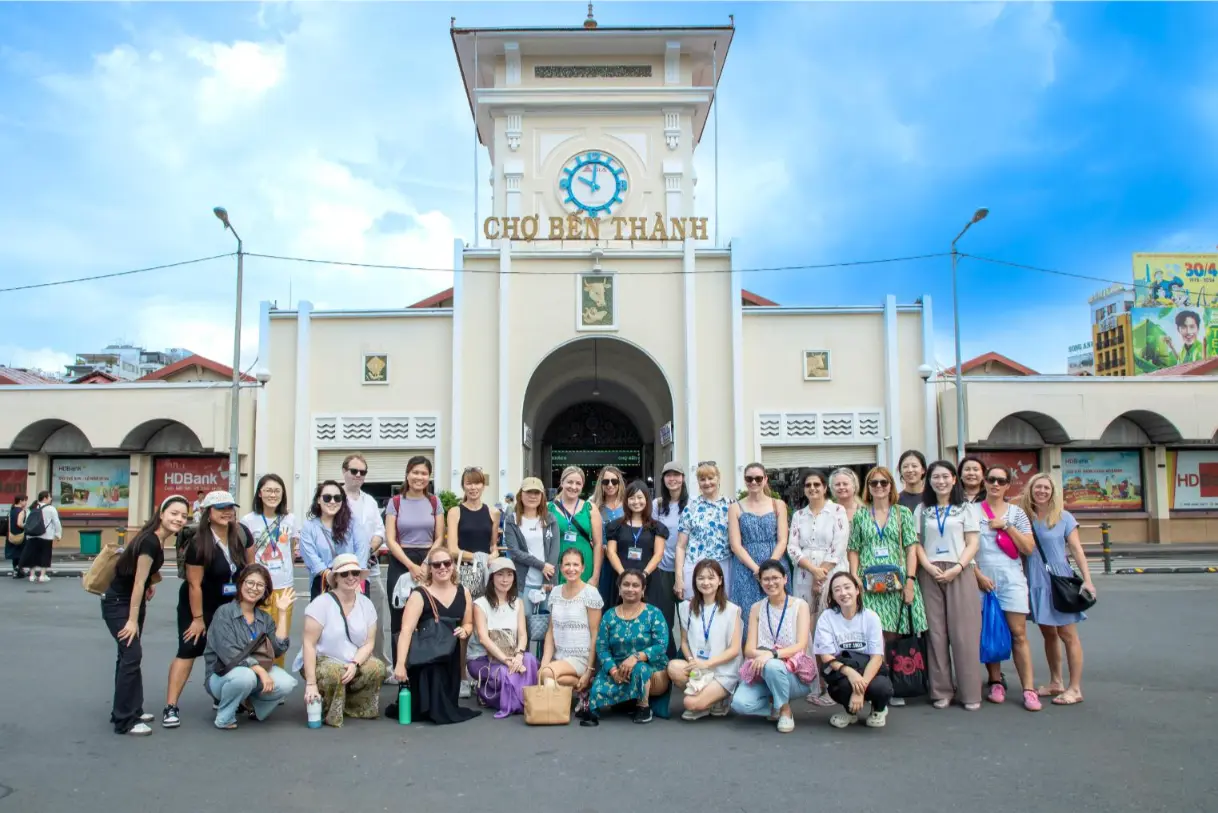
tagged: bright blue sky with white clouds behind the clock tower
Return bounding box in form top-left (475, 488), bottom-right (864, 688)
top-left (0, 2), bottom-right (1218, 372)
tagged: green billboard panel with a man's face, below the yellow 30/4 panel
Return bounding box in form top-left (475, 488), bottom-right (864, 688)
top-left (1129, 307), bottom-right (1218, 374)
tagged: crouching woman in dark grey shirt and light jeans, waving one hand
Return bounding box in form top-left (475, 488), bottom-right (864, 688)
top-left (203, 564), bottom-right (296, 729)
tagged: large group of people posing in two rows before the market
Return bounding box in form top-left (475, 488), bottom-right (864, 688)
top-left (90, 451), bottom-right (1095, 735)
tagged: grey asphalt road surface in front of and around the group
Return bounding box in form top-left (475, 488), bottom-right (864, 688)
top-left (0, 575), bottom-right (1218, 813)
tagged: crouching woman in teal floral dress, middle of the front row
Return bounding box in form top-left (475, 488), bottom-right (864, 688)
top-left (580, 569), bottom-right (669, 725)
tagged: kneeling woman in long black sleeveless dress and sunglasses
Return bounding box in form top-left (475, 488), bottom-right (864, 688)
top-left (393, 545), bottom-right (482, 725)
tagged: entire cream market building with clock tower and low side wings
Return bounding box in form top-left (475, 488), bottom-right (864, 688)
top-left (0, 14), bottom-right (1218, 545)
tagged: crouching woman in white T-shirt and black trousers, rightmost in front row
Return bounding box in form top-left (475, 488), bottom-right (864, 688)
top-left (812, 573), bottom-right (893, 729)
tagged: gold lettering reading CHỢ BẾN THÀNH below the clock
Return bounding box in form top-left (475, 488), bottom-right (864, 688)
top-left (482, 212), bottom-right (709, 243)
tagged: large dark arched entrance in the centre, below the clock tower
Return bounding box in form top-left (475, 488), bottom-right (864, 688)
top-left (524, 336), bottom-right (674, 491)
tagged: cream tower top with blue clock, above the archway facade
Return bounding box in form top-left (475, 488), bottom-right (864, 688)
top-left (452, 12), bottom-right (734, 249)
